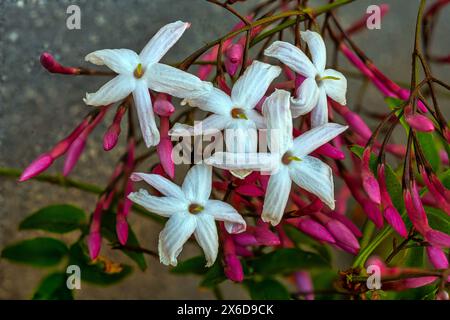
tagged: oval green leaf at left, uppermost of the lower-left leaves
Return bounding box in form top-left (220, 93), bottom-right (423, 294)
top-left (19, 204), bottom-right (86, 233)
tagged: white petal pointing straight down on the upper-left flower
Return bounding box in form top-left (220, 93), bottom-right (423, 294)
top-left (133, 81), bottom-right (159, 147)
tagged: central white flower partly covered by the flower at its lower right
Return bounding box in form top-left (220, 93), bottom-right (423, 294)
top-left (170, 61), bottom-right (281, 153)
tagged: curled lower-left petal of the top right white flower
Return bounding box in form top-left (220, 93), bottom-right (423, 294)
top-left (291, 78), bottom-right (320, 118)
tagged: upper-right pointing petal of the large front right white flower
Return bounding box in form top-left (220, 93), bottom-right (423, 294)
top-left (292, 122), bottom-right (348, 158)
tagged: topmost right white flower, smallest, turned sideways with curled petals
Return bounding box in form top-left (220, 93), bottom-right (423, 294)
top-left (264, 31), bottom-right (347, 127)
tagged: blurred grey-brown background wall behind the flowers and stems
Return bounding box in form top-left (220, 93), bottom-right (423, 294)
top-left (0, 0), bottom-right (450, 299)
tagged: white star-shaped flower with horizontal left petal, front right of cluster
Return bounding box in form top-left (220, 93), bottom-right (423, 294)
top-left (206, 90), bottom-right (347, 225)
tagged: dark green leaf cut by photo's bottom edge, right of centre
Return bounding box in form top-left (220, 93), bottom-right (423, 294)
top-left (244, 278), bottom-right (290, 300)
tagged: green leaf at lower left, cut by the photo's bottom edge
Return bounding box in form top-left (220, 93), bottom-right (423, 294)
top-left (33, 272), bottom-right (73, 300)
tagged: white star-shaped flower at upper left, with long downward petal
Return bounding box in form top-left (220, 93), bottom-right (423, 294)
top-left (84, 21), bottom-right (210, 147)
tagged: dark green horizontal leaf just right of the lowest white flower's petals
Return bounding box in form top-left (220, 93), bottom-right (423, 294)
top-left (248, 248), bottom-right (329, 276)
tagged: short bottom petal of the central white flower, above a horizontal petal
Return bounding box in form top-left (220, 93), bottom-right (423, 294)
top-left (225, 119), bottom-right (258, 153)
